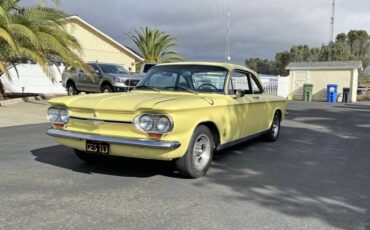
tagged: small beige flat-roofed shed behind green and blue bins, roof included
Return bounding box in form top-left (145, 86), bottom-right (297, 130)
top-left (286, 61), bottom-right (362, 102)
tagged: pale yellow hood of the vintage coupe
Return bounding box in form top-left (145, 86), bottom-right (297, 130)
top-left (49, 91), bottom-right (213, 112)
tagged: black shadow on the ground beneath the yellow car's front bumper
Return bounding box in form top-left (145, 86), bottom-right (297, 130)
top-left (31, 145), bottom-right (183, 178)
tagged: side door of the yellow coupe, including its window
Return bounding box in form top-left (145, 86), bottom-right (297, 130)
top-left (225, 71), bottom-right (258, 140)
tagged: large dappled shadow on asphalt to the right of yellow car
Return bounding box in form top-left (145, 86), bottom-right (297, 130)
top-left (204, 106), bottom-right (370, 229)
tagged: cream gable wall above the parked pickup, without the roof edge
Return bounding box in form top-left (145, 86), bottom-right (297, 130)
top-left (66, 21), bottom-right (135, 71)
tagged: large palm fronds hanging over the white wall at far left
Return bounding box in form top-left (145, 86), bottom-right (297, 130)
top-left (0, 0), bottom-right (90, 97)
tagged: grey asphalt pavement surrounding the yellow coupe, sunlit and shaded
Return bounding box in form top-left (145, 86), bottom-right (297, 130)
top-left (0, 102), bottom-right (370, 229)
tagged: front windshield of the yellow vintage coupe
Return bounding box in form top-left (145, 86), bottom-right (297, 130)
top-left (136, 65), bottom-right (228, 93)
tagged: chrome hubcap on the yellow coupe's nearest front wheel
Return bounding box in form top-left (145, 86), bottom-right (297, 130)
top-left (193, 134), bottom-right (211, 170)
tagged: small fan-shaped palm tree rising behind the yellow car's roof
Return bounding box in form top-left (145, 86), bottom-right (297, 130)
top-left (125, 27), bottom-right (183, 63)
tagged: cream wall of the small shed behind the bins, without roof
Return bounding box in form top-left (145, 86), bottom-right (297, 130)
top-left (289, 69), bottom-right (358, 102)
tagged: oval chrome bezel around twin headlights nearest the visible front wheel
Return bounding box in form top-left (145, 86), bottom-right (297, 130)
top-left (134, 113), bottom-right (174, 134)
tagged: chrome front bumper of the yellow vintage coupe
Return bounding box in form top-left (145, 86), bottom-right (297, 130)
top-left (46, 128), bottom-right (181, 149)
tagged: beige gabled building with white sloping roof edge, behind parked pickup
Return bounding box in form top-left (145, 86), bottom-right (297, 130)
top-left (66, 16), bottom-right (143, 72)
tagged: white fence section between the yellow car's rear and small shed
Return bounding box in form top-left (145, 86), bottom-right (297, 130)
top-left (259, 75), bottom-right (289, 98)
